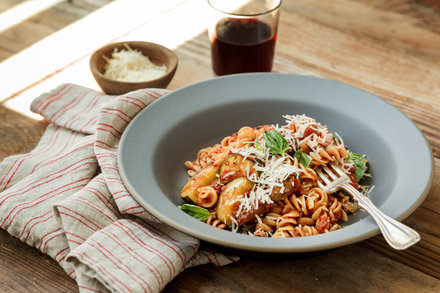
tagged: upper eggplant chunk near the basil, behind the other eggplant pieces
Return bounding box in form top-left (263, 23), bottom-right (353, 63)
top-left (220, 154), bottom-right (255, 184)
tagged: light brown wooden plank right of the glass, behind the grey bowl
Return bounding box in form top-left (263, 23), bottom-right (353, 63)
top-left (275, 1), bottom-right (440, 156)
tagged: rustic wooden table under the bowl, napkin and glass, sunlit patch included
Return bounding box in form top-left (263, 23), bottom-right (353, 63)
top-left (0, 0), bottom-right (440, 292)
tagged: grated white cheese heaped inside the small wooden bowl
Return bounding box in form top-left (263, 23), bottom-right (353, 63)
top-left (104, 44), bottom-right (167, 82)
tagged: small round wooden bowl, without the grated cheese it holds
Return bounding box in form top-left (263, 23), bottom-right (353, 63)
top-left (90, 41), bottom-right (178, 95)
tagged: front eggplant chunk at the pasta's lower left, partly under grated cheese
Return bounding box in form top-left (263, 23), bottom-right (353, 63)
top-left (217, 177), bottom-right (254, 226)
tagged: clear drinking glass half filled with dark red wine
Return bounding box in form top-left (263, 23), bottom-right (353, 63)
top-left (208, 0), bottom-right (281, 75)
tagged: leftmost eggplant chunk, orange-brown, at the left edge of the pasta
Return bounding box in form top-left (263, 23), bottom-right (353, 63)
top-left (180, 165), bottom-right (220, 204)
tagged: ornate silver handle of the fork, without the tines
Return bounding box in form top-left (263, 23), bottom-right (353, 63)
top-left (341, 184), bottom-right (420, 250)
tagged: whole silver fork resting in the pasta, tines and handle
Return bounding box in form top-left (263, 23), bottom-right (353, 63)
top-left (316, 164), bottom-right (420, 250)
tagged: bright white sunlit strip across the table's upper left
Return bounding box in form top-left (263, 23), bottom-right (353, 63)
top-left (0, 0), bottom-right (189, 99)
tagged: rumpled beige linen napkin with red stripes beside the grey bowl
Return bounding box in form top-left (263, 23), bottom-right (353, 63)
top-left (0, 84), bottom-right (237, 292)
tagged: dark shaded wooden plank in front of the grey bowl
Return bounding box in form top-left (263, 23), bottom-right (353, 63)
top-left (163, 245), bottom-right (440, 293)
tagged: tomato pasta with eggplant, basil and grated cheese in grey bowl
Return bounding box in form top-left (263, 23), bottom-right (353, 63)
top-left (180, 115), bottom-right (368, 237)
